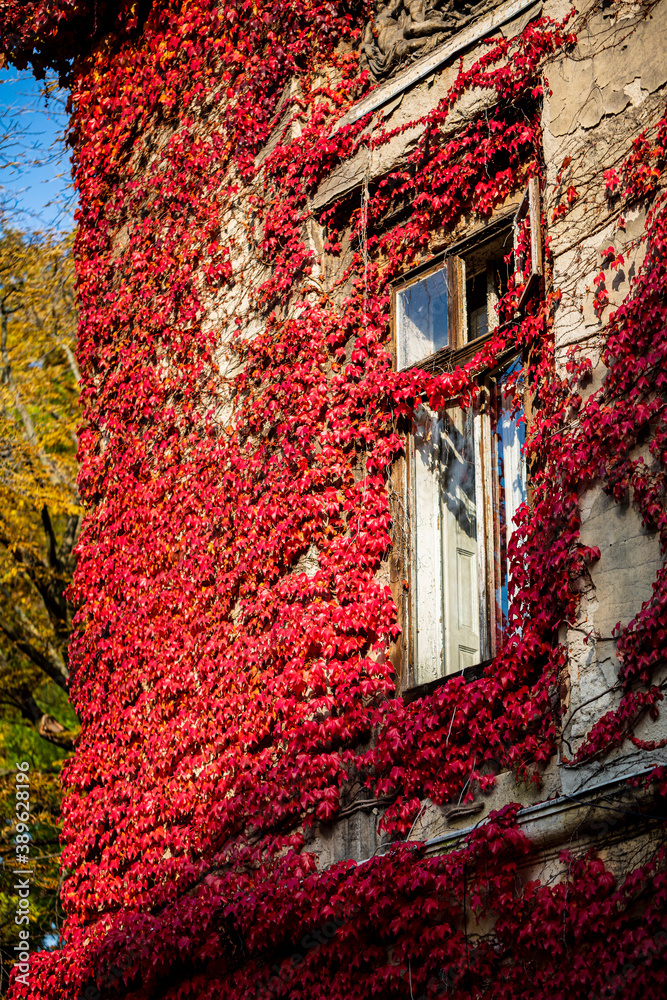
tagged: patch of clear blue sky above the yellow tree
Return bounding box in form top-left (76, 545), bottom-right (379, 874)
top-left (0, 68), bottom-right (75, 232)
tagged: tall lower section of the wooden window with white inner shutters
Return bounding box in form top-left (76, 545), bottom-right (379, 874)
top-left (409, 368), bottom-right (526, 684)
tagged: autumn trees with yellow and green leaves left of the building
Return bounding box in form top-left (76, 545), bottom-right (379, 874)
top-left (0, 227), bottom-right (80, 986)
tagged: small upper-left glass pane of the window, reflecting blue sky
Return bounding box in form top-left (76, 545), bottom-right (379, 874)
top-left (396, 268), bottom-right (449, 370)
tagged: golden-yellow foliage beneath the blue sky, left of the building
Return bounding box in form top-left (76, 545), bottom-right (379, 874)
top-left (0, 229), bottom-right (80, 698)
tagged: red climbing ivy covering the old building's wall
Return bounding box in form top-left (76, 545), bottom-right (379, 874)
top-left (0, 0), bottom-right (667, 1000)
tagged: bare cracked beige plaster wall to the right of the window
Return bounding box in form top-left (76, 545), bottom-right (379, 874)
top-left (543, 2), bottom-right (667, 790)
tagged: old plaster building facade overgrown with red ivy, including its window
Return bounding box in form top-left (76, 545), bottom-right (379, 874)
top-left (0, 0), bottom-right (667, 1000)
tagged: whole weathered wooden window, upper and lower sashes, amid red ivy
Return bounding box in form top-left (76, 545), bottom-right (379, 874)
top-left (394, 185), bottom-right (541, 687)
